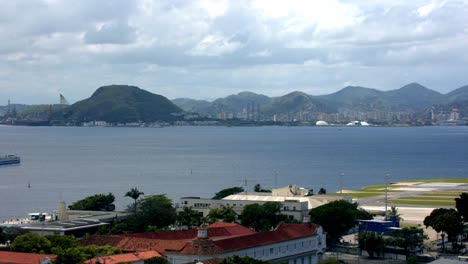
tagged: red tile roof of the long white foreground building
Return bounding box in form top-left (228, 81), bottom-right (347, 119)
top-left (81, 223), bottom-right (318, 254)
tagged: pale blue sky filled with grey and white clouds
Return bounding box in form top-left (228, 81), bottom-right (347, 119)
top-left (0, 0), bottom-right (468, 105)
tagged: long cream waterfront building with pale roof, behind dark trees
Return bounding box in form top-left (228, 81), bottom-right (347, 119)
top-left (178, 185), bottom-right (351, 222)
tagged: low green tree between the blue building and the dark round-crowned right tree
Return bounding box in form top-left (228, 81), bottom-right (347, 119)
top-left (386, 226), bottom-right (428, 256)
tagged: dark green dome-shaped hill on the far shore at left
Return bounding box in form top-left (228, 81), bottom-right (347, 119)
top-left (64, 85), bottom-right (183, 123)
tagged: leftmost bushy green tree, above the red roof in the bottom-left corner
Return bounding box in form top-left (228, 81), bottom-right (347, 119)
top-left (10, 233), bottom-right (51, 254)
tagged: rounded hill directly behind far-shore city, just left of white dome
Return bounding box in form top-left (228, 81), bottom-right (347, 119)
top-left (262, 91), bottom-right (336, 114)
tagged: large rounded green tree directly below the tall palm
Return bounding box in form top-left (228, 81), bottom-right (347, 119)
top-left (134, 194), bottom-right (176, 232)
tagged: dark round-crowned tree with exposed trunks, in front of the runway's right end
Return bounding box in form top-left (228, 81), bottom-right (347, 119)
top-left (424, 208), bottom-right (463, 250)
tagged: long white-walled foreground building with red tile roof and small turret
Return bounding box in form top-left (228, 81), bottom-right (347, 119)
top-left (82, 222), bottom-right (326, 264)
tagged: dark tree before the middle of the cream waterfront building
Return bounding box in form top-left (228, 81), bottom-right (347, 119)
top-left (240, 202), bottom-right (287, 232)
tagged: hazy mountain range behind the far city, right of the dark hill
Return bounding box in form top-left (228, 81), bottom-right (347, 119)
top-left (173, 83), bottom-right (468, 115)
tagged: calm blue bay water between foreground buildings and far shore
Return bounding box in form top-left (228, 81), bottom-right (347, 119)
top-left (0, 126), bottom-right (468, 219)
